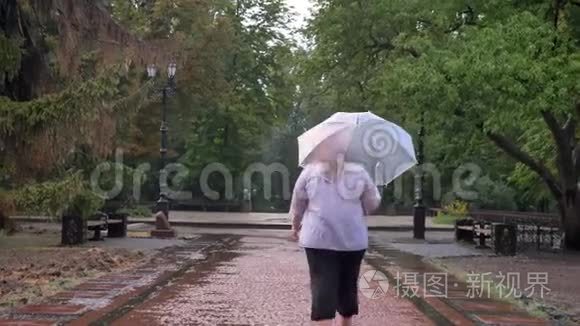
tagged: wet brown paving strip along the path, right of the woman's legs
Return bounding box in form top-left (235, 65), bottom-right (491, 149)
top-left (365, 237), bottom-right (560, 326)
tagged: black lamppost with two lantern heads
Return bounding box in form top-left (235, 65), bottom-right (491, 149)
top-left (147, 62), bottom-right (177, 219)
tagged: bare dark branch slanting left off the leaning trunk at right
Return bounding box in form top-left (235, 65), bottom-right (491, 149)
top-left (486, 132), bottom-right (562, 198)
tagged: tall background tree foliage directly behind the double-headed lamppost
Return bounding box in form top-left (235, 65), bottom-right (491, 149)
top-left (111, 0), bottom-right (297, 201)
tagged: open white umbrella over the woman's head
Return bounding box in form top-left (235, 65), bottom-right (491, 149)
top-left (298, 112), bottom-right (417, 185)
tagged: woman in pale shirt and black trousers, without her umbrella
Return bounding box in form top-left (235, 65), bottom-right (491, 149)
top-left (290, 150), bottom-right (381, 326)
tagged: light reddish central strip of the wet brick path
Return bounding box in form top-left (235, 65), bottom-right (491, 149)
top-left (112, 237), bottom-right (434, 326)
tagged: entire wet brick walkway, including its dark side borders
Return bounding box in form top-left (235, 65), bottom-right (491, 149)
top-left (0, 230), bottom-right (547, 326)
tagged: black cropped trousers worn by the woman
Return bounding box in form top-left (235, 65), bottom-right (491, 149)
top-left (305, 248), bottom-right (365, 321)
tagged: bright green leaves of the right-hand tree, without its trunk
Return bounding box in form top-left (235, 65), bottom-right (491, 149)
top-left (300, 0), bottom-right (580, 209)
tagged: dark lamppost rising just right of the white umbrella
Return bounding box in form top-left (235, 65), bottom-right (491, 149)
top-left (413, 112), bottom-right (425, 239)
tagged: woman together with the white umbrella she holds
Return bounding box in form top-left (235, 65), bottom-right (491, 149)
top-left (290, 112), bottom-right (417, 326)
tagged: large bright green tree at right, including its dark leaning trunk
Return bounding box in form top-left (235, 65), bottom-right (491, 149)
top-left (304, 0), bottom-right (580, 249)
